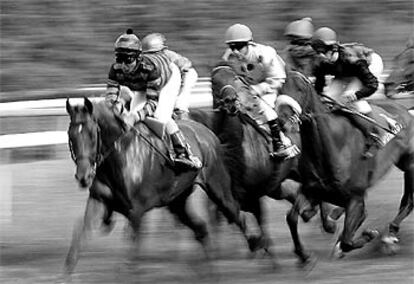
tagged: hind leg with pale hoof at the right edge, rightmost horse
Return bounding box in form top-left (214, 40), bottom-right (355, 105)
top-left (382, 164), bottom-right (414, 248)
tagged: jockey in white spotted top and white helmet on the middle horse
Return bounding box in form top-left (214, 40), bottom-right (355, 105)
top-left (222, 24), bottom-right (299, 159)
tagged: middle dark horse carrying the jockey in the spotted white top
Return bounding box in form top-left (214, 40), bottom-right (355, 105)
top-left (190, 63), bottom-right (335, 258)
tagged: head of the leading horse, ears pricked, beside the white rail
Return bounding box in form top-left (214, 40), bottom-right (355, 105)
top-left (66, 97), bottom-right (124, 188)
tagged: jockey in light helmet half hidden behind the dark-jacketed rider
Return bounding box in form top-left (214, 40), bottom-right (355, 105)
top-left (284, 18), bottom-right (315, 77)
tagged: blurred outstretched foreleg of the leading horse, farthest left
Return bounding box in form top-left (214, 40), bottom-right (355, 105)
top-left (64, 197), bottom-right (106, 276)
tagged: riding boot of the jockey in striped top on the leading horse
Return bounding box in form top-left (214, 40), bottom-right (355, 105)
top-left (170, 131), bottom-right (202, 170)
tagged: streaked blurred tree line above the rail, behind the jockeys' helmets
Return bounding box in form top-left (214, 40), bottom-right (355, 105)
top-left (0, 0), bottom-right (414, 92)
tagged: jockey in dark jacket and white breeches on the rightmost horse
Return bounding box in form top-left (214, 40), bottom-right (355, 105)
top-left (312, 27), bottom-right (385, 158)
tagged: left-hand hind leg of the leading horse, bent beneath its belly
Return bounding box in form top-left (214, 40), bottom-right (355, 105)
top-left (168, 186), bottom-right (211, 259)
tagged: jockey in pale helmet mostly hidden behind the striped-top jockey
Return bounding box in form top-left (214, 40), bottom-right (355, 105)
top-left (142, 33), bottom-right (198, 117)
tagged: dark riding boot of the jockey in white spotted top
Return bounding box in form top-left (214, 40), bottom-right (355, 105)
top-left (267, 118), bottom-right (300, 159)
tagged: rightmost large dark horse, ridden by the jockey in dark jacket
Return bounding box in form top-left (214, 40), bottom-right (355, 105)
top-left (278, 72), bottom-right (414, 258)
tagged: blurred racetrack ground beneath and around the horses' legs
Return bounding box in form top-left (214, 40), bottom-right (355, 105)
top-left (0, 159), bottom-right (414, 284)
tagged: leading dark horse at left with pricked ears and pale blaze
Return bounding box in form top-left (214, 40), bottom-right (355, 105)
top-left (65, 98), bottom-right (252, 274)
